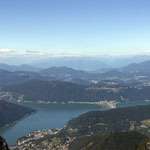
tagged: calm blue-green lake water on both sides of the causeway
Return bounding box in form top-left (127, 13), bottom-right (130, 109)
top-left (0, 101), bottom-right (150, 145)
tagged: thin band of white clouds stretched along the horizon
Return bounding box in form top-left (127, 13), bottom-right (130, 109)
top-left (0, 49), bottom-right (150, 57)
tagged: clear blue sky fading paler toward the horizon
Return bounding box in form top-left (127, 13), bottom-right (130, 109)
top-left (0, 0), bottom-right (150, 55)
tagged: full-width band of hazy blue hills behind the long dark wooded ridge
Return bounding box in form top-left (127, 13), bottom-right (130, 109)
top-left (0, 61), bottom-right (150, 87)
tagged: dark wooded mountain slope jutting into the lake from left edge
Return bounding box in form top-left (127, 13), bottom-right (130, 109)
top-left (0, 100), bottom-right (36, 128)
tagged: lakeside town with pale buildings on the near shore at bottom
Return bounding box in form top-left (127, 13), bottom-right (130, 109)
top-left (9, 128), bottom-right (74, 150)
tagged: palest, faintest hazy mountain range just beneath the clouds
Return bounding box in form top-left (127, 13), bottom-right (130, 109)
top-left (31, 55), bottom-right (150, 71)
